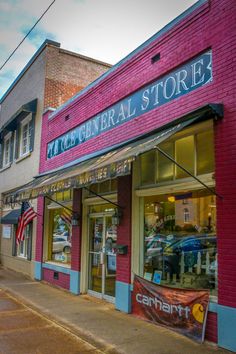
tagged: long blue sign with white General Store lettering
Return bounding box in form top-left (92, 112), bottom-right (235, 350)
top-left (47, 51), bottom-right (212, 159)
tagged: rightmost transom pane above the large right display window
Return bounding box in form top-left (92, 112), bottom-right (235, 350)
top-left (196, 130), bottom-right (215, 175)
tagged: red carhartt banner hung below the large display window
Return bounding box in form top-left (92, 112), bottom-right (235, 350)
top-left (132, 275), bottom-right (209, 342)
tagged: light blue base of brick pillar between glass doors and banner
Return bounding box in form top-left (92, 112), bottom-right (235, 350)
top-left (115, 281), bottom-right (131, 313)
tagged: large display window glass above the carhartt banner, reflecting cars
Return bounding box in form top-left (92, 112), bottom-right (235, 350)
top-left (144, 191), bottom-right (217, 295)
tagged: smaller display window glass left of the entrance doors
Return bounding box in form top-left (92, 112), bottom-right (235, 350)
top-left (47, 207), bottom-right (72, 264)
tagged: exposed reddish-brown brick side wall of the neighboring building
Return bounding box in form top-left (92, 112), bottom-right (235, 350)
top-left (44, 45), bottom-right (110, 108)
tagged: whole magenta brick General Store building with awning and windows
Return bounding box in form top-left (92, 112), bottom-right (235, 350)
top-left (6, 0), bottom-right (236, 350)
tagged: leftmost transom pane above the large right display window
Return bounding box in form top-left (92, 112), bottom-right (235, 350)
top-left (140, 150), bottom-right (156, 185)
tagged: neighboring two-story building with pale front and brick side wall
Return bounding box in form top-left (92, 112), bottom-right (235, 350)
top-left (0, 40), bottom-right (110, 277)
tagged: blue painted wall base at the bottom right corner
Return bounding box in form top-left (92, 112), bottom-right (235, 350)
top-left (218, 305), bottom-right (236, 353)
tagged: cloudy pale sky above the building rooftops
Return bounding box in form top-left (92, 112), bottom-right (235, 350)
top-left (0, 0), bottom-right (197, 98)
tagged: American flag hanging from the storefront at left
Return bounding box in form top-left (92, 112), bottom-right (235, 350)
top-left (16, 202), bottom-right (37, 245)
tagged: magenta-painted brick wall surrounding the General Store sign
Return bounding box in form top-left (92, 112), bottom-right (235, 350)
top-left (40, 0), bottom-right (236, 341)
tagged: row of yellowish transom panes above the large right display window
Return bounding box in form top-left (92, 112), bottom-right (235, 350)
top-left (140, 122), bottom-right (214, 186)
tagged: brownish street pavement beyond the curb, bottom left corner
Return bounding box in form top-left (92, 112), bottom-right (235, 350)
top-left (0, 289), bottom-right (103, 354)
